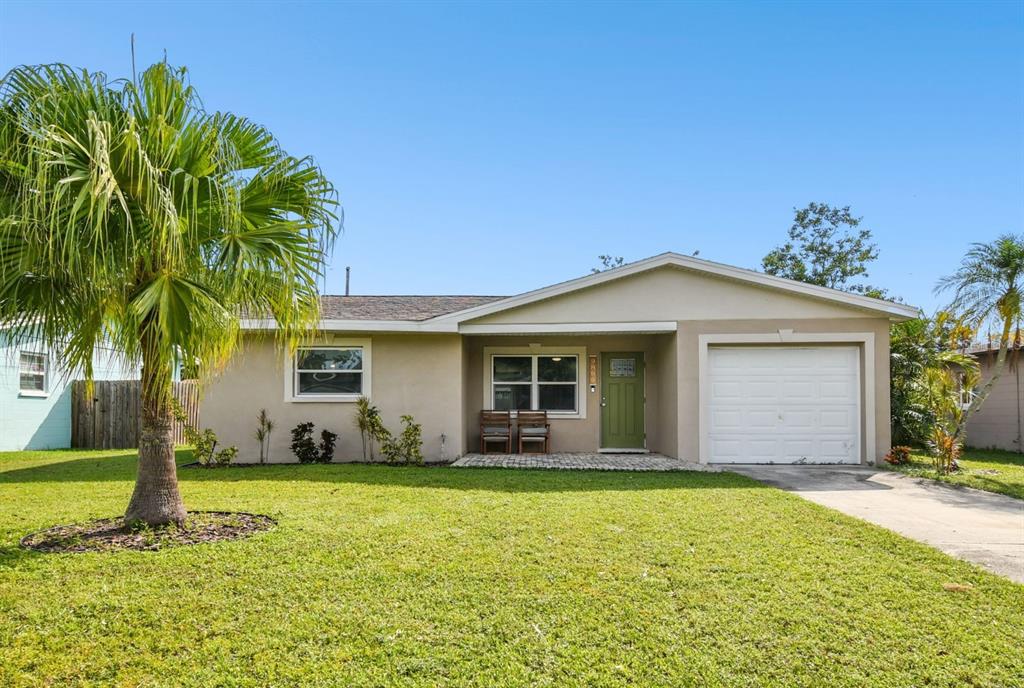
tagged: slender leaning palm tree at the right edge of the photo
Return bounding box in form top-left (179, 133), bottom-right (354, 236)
top-left (935, 234), bottom-right (1024, 440)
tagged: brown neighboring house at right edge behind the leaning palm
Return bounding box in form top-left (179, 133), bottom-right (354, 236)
top-left (966, 345), bottom-right (1024, 452)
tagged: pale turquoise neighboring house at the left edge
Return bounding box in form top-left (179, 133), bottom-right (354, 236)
top-left (0, 329), bottom-right (138, 452)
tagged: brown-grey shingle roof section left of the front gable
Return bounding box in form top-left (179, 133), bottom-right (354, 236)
top-left (321, 295), bottom-right (506, 320)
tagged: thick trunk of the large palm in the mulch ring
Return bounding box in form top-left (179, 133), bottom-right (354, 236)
top-left (125, 346), bottom-right (185, 525)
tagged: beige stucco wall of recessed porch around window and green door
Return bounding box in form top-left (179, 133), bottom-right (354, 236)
top-left (463, 334), bottom-right (676, 454)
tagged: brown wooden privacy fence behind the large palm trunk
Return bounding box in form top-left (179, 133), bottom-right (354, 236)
top-left (71, 380), bottom-right (199, 449)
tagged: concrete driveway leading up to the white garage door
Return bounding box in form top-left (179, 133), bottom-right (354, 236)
top-left (723, 466), bottom-right (1024, 583)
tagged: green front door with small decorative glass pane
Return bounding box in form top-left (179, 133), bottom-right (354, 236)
top-left (601, 353), bottom-right (645, 449)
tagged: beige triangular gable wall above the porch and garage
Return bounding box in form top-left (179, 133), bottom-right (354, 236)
top-left (472, 266), bottom-right (870, 325)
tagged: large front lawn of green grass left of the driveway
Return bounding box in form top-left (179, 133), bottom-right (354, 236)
top-left (0, 452), bottom-right (1024, 687)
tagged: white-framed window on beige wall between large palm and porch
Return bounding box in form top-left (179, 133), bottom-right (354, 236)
top-left (285, 340), bottom-right (370, 401)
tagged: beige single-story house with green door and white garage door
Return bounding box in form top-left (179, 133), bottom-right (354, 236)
top-left (201, 253), bottom-right (918, 464)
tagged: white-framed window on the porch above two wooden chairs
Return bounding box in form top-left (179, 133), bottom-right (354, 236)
top-left (484, 347), bottom-right (586, 418)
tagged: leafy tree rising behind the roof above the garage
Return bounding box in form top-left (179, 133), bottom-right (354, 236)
top-left (761, 203), bottom-right (885, 298)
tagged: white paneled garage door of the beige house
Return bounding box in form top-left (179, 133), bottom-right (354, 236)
top-left (706, 346), bottom-right (860, 464)
